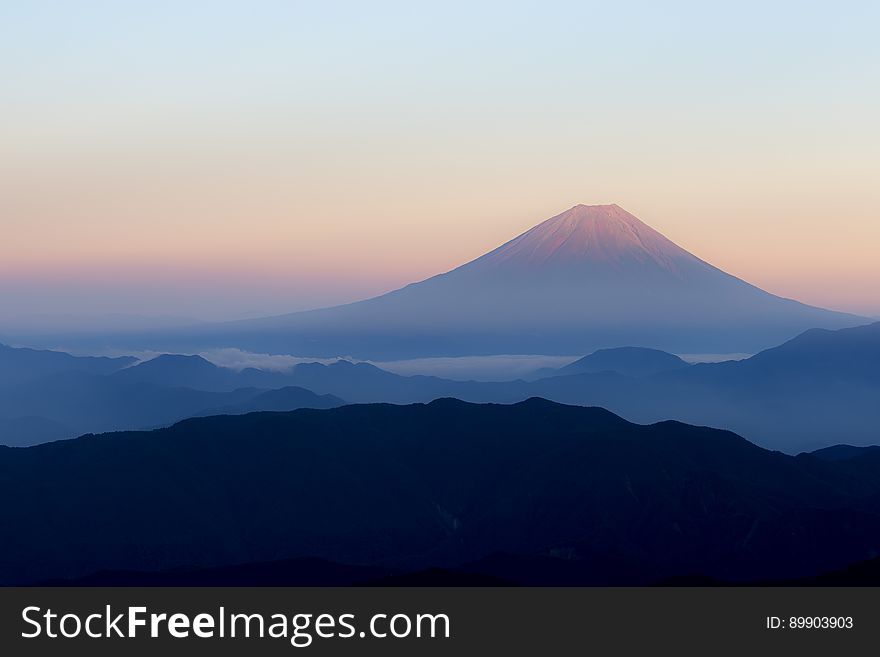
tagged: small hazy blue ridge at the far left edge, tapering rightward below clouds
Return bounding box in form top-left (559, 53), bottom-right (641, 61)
top-left (0, 344), bottom-right (137, 391)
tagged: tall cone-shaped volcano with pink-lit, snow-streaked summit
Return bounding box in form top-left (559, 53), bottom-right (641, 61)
top-left (189, 205), bottom-right (865, 360)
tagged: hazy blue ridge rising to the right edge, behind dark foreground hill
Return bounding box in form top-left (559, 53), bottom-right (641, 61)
top-left (512, 323), bottom-right (880, 453)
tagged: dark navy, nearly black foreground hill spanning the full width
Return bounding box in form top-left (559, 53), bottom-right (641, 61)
top-left (0, 399), bottom-right (880, 584)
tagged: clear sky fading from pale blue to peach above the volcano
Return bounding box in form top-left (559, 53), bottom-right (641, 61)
top-left (0, 0), bottom-right (880, 322)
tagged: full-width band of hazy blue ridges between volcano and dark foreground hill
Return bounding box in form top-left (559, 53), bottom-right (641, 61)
top-left (0, 323), bottom-right (880, 453)
